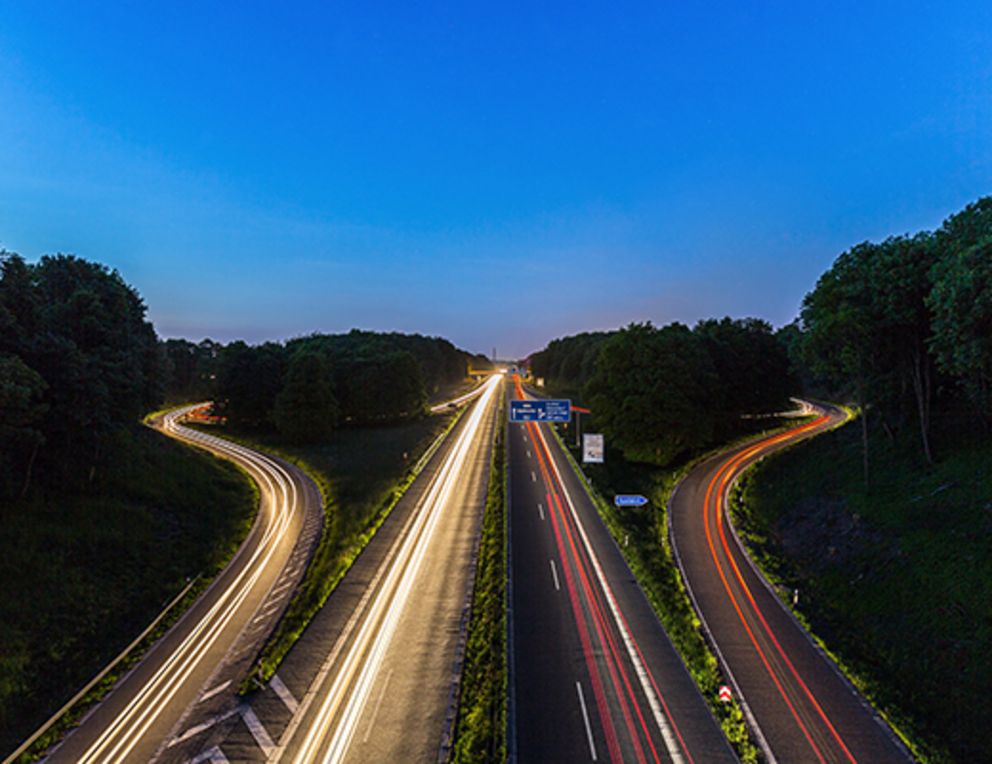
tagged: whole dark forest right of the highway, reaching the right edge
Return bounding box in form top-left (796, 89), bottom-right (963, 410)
top-left (529, 197), bottom-right (992, 472)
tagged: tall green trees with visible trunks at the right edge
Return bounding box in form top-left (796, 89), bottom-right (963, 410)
top-left (794, 197), bottom-right (992, 480)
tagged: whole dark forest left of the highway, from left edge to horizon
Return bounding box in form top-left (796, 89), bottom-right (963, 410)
top-left (0, 251), bottom-right (489, 498)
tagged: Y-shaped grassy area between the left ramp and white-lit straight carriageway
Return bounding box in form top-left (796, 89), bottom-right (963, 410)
top-left (197, 412), bottom-right (461, 692)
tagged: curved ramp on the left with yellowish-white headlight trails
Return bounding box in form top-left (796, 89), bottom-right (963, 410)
top-left (49, 406), bottom-right (323, 764)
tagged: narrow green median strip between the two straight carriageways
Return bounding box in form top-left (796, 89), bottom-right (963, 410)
top-left (452, 396), bottom-right (507, 764)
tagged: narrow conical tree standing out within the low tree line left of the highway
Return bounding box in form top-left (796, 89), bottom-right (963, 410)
top-left (275, 351), bottom-right (339, 443)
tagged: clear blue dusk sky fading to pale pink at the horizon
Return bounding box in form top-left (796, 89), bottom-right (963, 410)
top-left (0, 0), bottom-right (992, 356)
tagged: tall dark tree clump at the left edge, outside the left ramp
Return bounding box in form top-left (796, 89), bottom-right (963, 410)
top-left (0, 252), bottom-right (163, 496)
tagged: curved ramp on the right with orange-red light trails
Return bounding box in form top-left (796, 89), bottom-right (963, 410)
top-left (669, 407), bottom-right (911, 764)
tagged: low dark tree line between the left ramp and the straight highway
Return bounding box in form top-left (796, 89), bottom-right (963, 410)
top-left (165, 329), bottom-right (490, 442)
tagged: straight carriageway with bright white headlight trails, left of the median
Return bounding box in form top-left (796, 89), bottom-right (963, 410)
top-left (205, 375), bottom-right (503, 764)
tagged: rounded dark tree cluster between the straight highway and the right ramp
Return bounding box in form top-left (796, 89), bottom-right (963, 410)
top-left (530, 318), bottom-right (796, 464)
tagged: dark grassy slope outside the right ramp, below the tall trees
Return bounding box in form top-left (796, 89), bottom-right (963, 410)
top-left (733, 418), bottom-right (992, 764)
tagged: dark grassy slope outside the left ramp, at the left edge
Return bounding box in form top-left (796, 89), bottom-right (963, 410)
top-left (0, 428), bottom-right (257, 761)
